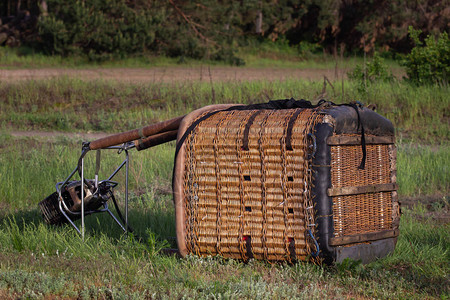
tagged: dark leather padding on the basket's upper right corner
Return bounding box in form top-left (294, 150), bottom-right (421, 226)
top-left (323, 105), bottom-right (394, 135)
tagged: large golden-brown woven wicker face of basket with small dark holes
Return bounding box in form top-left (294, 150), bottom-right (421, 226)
top-left (184, 109), bottom-right (318, 260)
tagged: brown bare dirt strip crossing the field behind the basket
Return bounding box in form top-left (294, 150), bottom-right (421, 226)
top-left (0, 67), bottom-right (345, 82)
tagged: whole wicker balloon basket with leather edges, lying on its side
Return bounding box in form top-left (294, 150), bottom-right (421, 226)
top-left (173, 101), bottom-right (399, 263)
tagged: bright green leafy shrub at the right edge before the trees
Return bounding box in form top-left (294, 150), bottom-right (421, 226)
top-left (403, 26), bottom-right (450, 85)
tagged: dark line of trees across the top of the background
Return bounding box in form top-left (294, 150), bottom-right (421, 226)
top-left (0, 0), bottom-right (450, 64)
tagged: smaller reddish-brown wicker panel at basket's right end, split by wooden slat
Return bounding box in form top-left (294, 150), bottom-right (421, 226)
top-left (331, 145), bottom-right (393, 237)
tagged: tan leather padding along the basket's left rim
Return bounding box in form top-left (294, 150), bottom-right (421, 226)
top-left (173, 104), bottom-right (236, 257)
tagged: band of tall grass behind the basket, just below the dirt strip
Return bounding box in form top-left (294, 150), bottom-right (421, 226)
top-left (0, 77), bottom-right (450, 144)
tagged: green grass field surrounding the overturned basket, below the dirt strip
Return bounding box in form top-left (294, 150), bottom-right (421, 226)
top-left (0, 65), bottom-right (450, 299)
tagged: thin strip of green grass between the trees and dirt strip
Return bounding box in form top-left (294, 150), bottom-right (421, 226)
top-left (0, 42), bottom-right (400, 69)
